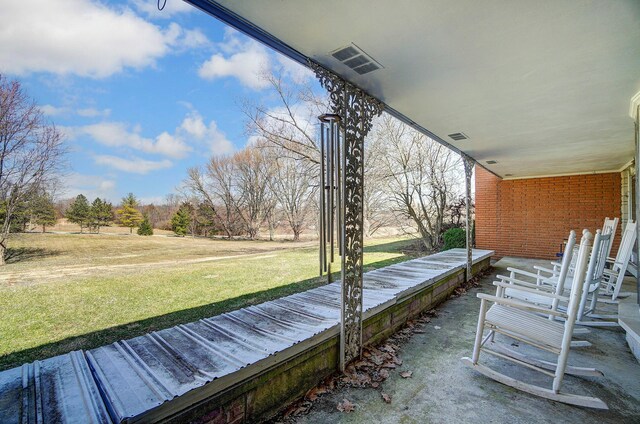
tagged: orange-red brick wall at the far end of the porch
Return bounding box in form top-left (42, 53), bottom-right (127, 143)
top-left (475, 167), bottom-right (622, 258)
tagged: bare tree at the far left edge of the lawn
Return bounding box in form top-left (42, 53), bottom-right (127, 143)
top-left (0, 75), bottom-right (65, 265)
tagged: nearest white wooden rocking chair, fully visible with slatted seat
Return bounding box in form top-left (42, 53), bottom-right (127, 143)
top-left (462, 233), bottom-right (608, 409)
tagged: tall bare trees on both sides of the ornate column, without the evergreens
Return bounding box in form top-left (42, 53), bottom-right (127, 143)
top-left (183, 69), bottom-right (472, 251)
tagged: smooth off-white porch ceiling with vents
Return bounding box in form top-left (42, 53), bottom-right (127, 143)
top-left (186, 0), bottom-right (640, 177)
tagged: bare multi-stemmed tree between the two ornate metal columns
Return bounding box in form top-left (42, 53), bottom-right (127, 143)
top-left (376, 115), bottom-right (464, 250)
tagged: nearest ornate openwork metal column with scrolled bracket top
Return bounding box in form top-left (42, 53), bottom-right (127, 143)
top-left (309, 61), bottom-right (383, 371)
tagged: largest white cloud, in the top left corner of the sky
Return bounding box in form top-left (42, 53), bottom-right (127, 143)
top-left (0, 0), bottom-right (206, 78)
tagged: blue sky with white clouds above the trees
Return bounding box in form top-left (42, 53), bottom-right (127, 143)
top-left (0, 0), bottom-right (319, 203)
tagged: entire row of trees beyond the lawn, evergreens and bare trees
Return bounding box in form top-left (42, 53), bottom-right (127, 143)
top-left (0, 74), bottom-right (472, 265)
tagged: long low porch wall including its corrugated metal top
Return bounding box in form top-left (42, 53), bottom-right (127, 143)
top-left (0, 249), bottom-right (493, 423)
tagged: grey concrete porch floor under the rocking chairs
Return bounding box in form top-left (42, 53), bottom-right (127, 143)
top-left (296, 258), bottom-right (640, 424)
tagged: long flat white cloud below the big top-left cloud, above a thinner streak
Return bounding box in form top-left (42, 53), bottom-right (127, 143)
top-left (72, 122), bottom-right (192, 159)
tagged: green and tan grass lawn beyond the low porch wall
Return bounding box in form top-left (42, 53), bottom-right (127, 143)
top-left (0, 234), bottom-right (420, 369)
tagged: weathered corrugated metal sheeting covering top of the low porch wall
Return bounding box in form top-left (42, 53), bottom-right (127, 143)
top-left (0, 249), bottom-right (492, 424)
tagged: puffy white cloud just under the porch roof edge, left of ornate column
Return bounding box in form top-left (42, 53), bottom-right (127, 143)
top-left (198, 30), bottom-right (270, 90)
